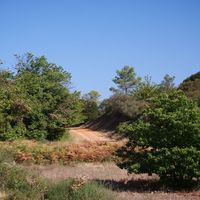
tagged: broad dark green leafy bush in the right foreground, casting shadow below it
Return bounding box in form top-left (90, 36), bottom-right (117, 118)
top-left (118, 91), bottom-right (200, 181)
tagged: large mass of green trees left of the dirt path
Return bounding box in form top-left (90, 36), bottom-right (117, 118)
top-left (0, 54), bottom-right (84, 140)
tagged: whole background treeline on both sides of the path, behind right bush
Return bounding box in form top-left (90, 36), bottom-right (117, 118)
top-left (0, 53), bottom-right (200, 140)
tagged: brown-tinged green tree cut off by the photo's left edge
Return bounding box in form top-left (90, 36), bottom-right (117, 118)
top-left (0, 71), bottom-right (30, 140)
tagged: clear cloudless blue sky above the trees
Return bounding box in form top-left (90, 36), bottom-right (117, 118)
top-left (0, 0), bottom-right (200, 98)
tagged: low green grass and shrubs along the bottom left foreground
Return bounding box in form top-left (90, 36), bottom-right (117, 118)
top-left (0, 159), bottom-right (113, 200)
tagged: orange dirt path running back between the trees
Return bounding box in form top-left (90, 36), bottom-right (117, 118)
top-left (70, 128), bottom-right (113, 142)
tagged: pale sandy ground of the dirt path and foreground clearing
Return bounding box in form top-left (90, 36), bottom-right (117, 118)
top-left (30, 128), bottom-right (200, 200)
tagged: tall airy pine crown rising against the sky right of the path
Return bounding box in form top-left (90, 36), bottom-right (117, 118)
top-left (110, 66), bottom-right (141, 94)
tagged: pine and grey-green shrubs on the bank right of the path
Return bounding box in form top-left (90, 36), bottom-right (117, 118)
top-left (100, 66), bottom-right (176, 125)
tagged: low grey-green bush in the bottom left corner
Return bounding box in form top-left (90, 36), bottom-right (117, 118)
top-left (0, 164), bottom-right (47, 200)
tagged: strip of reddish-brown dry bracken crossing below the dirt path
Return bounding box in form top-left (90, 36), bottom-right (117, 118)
top-left (0, 140), bottom-right (121, 164)
